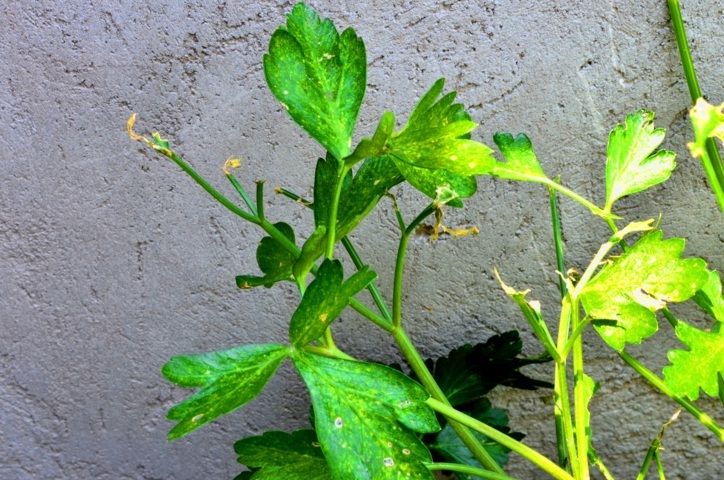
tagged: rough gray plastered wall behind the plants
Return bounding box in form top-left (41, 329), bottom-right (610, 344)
top-left (0, 0), bottom-right (724, 479)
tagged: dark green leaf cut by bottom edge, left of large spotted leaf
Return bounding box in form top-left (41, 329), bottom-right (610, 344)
top-left (234, 428), bottom-right (332, 480)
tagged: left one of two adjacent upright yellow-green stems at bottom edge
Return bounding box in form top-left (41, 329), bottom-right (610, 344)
top-left (553, 295), bottom-right (580, 478)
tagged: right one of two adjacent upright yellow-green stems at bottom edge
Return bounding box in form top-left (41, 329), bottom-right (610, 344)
top-left (571, 298), bottom-right (590, 479)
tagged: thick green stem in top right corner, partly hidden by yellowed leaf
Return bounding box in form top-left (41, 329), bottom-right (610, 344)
top-left (668, 0), bottom-right (724, 212)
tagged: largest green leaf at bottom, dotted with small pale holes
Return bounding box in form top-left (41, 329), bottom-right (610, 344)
top-left (294, 351), bottom-right (440, 480)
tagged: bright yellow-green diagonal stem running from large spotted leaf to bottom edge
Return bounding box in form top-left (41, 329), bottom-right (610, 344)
top-left (426, 398), bottom-right (573, 480)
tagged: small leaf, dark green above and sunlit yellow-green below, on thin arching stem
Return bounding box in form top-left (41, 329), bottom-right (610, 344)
top-left (492, 132), bottom-right (550, 183)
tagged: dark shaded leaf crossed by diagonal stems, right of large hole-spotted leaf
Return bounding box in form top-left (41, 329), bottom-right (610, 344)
top-left (429, 398), bottom-right (525, 480)
